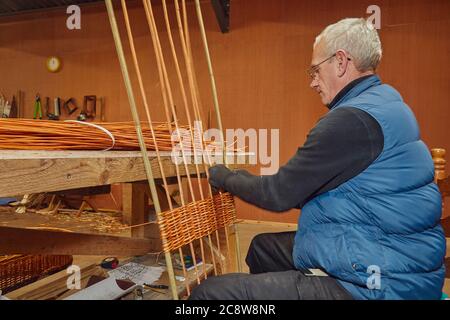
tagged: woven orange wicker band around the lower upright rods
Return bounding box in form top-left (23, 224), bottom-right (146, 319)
top-left (158, 193), bottom-right (236, 252)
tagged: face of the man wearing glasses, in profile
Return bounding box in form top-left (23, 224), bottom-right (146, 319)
top-left (310, 42), bottom-right (338, 105)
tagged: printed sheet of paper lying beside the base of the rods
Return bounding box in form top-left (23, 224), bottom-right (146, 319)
top-left (108, 262), bottom-right (165, 285)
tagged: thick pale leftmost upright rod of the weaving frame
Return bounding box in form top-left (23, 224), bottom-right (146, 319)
top-left (105, 0), bottom-right (178, 300)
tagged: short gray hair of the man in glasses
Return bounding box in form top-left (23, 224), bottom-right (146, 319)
top-left (314, 18), bottom-right (383, 72)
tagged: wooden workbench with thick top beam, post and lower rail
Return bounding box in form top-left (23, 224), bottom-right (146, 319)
top-left (0, 150), bottom-right (248, 255)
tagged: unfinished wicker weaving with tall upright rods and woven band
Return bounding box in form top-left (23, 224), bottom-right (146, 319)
top-left (101, 0), bottom-right (241, 299)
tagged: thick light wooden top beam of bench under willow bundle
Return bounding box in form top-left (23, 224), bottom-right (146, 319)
top-left (0, 150), bottom-right (248, 197)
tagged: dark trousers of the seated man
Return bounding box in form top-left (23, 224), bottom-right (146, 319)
top-left (190, 232), bottom-right (352, 300)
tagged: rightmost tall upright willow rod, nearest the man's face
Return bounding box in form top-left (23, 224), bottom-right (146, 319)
top-left (193, 0), bottom-right (242, 272)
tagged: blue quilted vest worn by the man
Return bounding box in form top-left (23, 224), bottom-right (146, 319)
top-left (293, 76), bottom-right (446, 299)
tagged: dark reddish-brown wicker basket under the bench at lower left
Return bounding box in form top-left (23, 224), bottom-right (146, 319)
top-left (0, 255), bottom-right (73, 294)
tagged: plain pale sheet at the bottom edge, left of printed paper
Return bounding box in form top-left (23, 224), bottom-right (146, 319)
top-left (64, 277), bottom-right (137, 300)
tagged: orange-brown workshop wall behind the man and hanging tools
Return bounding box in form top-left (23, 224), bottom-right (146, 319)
top-left (0, 0), bottom-right (450, 222)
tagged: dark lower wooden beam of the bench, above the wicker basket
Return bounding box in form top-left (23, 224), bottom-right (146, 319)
top-left (0, 227), bottom-right (155, 256)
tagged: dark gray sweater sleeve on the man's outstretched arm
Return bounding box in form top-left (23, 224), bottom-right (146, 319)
top-left (219, 107), bottom-right (384, 212)
